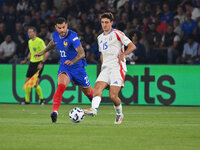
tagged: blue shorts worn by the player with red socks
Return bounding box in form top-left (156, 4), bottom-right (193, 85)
top-left (58, 65), bottom-right (90, 87)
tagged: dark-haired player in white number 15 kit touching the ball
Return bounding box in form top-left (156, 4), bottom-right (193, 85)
top-left (84, 12), bottom-right (136, 124)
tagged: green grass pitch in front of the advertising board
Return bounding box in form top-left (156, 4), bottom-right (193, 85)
top-left (0, 104), bottom-right (200, 150)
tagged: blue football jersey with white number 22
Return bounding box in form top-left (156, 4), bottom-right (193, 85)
top-left (52, 29), bottom-right (87, 68)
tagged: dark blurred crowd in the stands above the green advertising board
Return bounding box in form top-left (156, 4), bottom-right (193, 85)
top-left (0, 0), bottom-right (200, 64)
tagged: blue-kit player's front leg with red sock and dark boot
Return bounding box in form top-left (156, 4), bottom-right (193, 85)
top-left (51, 73), bottom-right (70, 122)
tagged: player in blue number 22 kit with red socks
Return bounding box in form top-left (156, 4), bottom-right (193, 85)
top-left (35, 17), bottom-right (93, 122)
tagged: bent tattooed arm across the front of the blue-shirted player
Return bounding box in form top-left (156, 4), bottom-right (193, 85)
top-left (64, 45), bottom-right (85, 65)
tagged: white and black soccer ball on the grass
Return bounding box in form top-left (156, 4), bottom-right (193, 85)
top-left (69, 107), bottom-right (84, 123)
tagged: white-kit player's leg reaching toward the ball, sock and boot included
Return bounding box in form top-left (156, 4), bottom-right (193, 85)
top-left (84, 81), bottom-right (108, 116)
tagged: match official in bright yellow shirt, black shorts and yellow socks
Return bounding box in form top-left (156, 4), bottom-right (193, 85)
top-left (21, 27), bottom-right (49, 105)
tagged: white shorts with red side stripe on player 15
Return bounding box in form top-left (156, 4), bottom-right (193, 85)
top-left (96, 68), bottom-right (126, 87)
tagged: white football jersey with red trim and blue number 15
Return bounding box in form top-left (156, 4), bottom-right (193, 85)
top-left (97, 29), bottom-right (131, 71)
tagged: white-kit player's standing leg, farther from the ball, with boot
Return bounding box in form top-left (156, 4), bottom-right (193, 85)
top-left (109, 86), bottom-right (124, 124)
